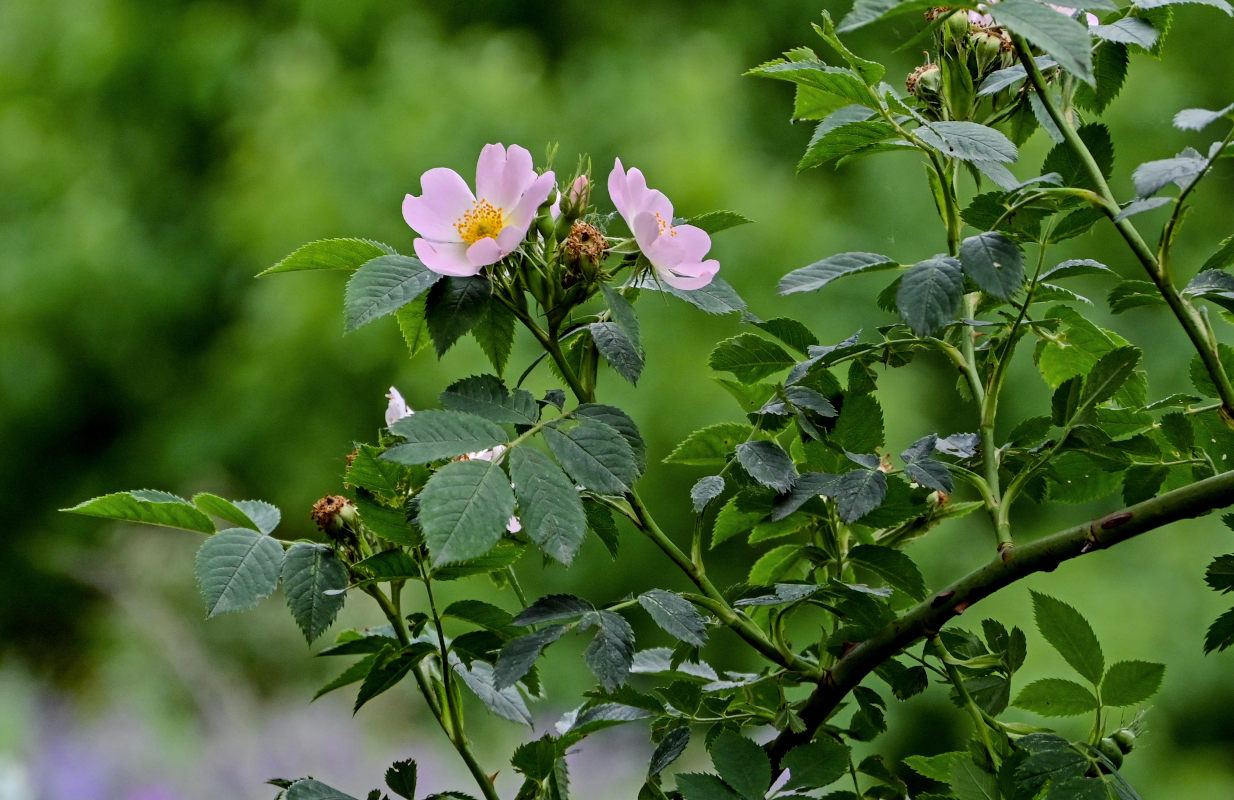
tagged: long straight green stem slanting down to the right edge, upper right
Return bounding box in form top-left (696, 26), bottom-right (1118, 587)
top-left (1012, 33), bottom-right (1234, 423)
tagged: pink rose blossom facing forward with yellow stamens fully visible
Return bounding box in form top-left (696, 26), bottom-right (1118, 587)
top-left (402, 144), bottom-right (554, 277)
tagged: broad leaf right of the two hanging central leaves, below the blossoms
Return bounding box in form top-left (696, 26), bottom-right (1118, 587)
top-left (543, 419), bottom-right (638, 495)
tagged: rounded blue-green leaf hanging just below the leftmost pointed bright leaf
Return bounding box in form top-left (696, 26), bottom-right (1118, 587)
top-left (195, 528), bottom-right (283, 617)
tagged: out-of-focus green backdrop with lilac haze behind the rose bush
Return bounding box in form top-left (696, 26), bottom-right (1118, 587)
top-left (7, 0), bottom-right (1234, 800)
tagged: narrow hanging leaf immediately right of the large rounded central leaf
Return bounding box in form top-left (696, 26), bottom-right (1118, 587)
top-left (510, 447), bottom-right (587, 567)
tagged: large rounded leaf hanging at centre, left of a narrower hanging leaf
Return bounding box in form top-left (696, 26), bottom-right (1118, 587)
top-left (419, 456), bottom-right (515, 565)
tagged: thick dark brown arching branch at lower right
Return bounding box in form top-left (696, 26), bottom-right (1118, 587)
top-left (768, 472), bottom-right (1234, 768)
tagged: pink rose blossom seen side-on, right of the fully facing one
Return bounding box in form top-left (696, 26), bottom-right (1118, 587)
top-left (608, 158), bottom-right (719, 289)
